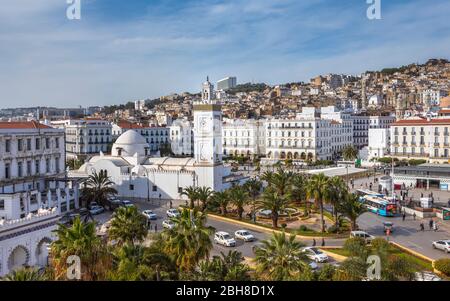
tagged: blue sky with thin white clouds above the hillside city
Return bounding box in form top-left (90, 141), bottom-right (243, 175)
top-left (0, 0), bottom-right (450, 108)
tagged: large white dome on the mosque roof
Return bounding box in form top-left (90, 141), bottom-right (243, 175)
top-left (111, 130), bottom-right (149, 157)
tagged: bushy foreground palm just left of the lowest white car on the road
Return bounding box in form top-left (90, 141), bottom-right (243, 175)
top-left (254, 232), bottom-right (308, 281)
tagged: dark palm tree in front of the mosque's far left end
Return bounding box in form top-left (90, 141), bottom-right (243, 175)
top-left (81, 171), bottom-right (117, 208)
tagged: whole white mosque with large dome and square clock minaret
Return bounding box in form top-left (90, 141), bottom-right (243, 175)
top-left (79, 79), bottom-right (239, 199)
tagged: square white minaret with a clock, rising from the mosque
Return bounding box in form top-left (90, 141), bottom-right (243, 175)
top-left (194, 78), bottom-right (223, 191)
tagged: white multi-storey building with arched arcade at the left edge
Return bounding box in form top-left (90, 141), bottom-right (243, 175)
top-left (0, 121), bottom-right (78, 276)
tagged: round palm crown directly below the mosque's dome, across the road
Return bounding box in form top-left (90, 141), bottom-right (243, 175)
top-left (108, 206), bottom-right (148, 246)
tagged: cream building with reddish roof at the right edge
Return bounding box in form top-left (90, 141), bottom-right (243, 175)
top-left (391, 118), bottom-right (450, 163)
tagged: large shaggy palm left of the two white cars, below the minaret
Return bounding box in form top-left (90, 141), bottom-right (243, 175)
top-left (163, 209), bottom-right (214, 271)
